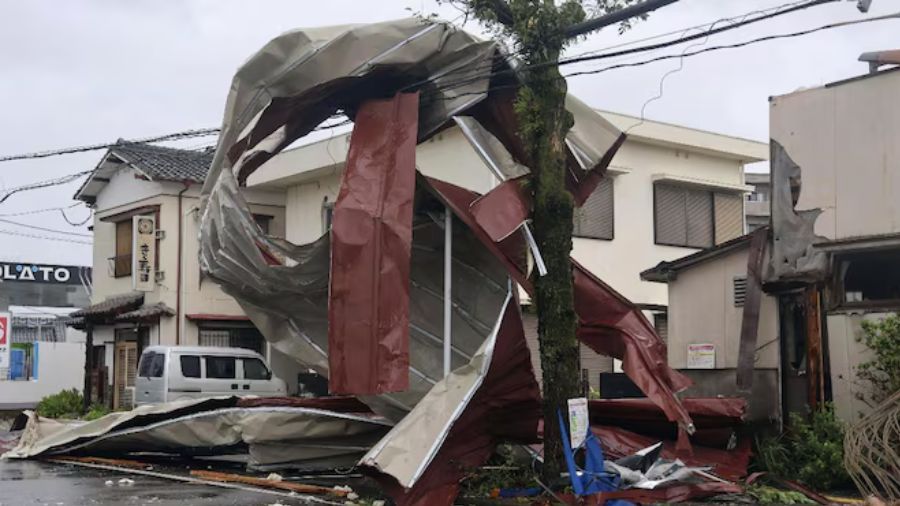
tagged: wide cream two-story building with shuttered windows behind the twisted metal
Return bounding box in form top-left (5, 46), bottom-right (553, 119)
top-left (248, 111), bottom-right (768, 387)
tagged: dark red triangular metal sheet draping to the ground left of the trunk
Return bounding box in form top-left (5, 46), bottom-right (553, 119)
top-left (366, 296), bottom-right (541, 506)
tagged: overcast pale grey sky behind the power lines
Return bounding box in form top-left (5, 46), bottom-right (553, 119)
top-left (0, 0), bottom-right (900, 264)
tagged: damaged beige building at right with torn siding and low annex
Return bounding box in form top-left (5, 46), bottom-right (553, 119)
top-left (644, 58), bottom-right (900, 421)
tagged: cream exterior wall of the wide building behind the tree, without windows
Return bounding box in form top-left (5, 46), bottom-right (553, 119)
top-left (268, 124), bottom-right (760, 305)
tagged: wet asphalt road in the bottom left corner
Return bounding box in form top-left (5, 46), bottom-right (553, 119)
top-left (0, 460), bottom-right (324, 506)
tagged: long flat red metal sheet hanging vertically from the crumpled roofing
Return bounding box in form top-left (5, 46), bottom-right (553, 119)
top-left (328, 93), bottom-right (419, 395)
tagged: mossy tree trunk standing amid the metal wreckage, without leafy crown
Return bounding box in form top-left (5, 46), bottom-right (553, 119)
top-left (516, 50), bottom-right (580, 484)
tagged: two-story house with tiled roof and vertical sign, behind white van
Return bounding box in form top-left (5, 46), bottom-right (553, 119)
top-left (73, 144), bottom-right (299, 407)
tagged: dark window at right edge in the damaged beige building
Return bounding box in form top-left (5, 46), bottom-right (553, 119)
top-left (838, 250), bottom-right (900, 307)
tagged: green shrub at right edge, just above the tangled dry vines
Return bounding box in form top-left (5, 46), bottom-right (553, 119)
top-left (857, 314), bottom-right (900, 405)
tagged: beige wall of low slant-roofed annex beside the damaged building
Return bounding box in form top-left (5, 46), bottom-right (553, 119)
top-left (663, 248), bottom-right (779, 369)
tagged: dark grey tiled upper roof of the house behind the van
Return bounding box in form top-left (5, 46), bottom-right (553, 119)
top-left (110, 144), bottom-right (214, 183)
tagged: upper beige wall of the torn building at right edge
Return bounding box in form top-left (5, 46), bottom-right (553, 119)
top-left (770, 72), bottom-right (900, 239)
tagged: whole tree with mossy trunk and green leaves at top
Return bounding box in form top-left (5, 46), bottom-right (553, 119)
top-left (442, 0), bottom-right (638, 482)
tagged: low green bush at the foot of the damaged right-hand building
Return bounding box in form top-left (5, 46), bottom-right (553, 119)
top-left (757, 404), bottom-right (852, 490)
